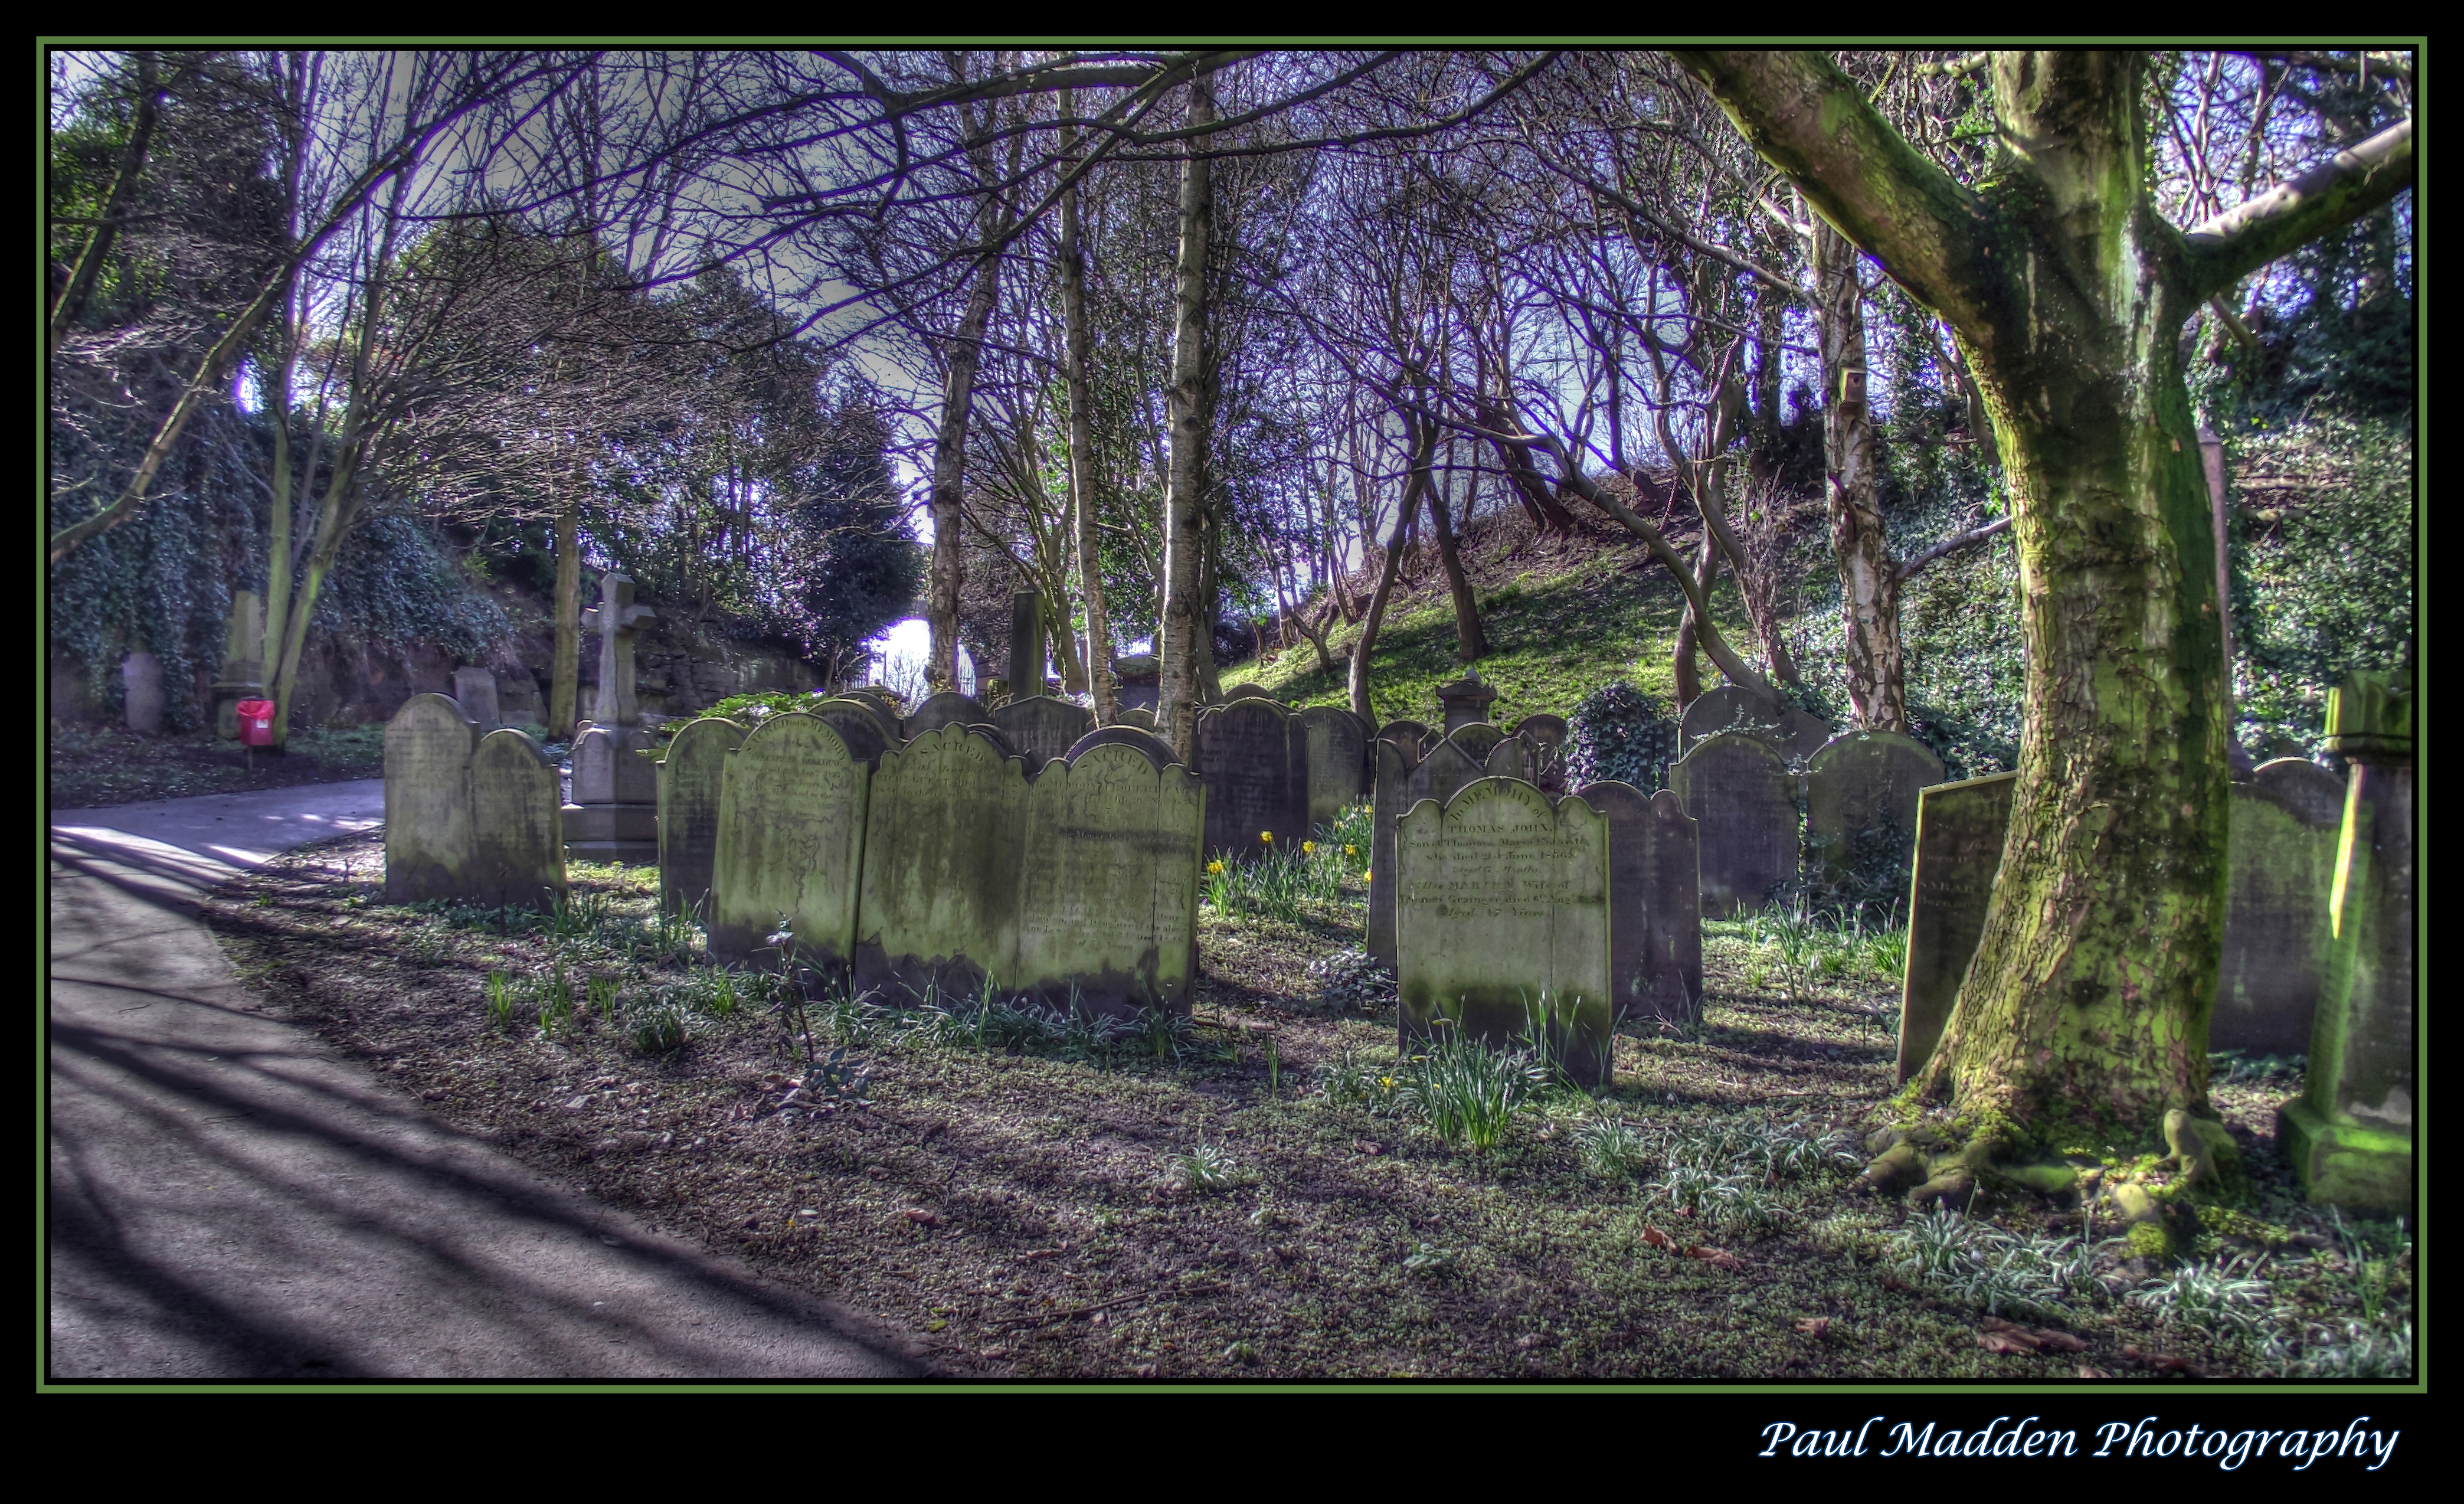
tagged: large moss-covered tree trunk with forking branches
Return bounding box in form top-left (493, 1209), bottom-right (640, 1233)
top-left (1680, 52), bottom-right (2412, 1149)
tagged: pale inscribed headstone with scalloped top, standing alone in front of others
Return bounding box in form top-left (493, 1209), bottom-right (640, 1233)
top-left (1395, 779), bottom-right (1614, 1085)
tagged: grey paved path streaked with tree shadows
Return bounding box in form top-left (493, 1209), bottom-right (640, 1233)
top-left (47, 779), bottom-right (924, 1381)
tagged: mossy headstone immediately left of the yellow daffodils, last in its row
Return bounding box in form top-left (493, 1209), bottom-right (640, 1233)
top-left (1005, 727), bottom-right (1205, 1016)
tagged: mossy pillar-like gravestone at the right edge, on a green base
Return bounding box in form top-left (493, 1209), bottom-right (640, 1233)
top-left (2277, 673), bottom-right (2420, 1213)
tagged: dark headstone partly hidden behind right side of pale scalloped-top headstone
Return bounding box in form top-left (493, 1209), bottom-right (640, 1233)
top-left (1575, 782), bottom-right (1703, 1023)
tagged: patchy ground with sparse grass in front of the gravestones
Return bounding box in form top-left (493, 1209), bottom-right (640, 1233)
top-left (210, 836), bottom-right (2412, 1381)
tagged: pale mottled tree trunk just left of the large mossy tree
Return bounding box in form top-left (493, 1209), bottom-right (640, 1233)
top-left (1814, 220), bottom-right (1907, 733)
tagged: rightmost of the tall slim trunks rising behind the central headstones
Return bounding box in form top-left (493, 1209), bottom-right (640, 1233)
top-left (1156, 74), bottom-right (1215, 762)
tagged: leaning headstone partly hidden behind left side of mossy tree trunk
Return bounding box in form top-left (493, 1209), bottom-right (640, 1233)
top-left (1900, 771), bottom-right (2018, 1085)
